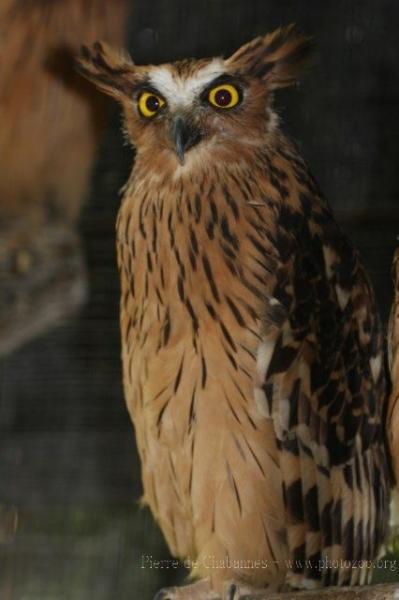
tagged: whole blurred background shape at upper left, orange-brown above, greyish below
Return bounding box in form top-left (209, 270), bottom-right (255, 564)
top-left (0, 0), bottom-right (128, 357)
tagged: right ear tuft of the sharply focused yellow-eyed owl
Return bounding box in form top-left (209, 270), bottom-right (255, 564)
top-left (227, 24), bottom-right (313, 89)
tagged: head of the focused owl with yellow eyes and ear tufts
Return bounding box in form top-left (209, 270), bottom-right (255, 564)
top-left (78, 25), bottom-right (312, 167)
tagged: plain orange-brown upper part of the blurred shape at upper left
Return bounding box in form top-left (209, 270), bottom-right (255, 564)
top-left (0, 0), bottom-right (127, 223)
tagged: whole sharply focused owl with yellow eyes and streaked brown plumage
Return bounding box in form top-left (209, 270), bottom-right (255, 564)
top-left (80, 27), bottom-right (389, 598)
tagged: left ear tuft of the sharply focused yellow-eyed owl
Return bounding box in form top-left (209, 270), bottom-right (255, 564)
top-left (75, 42), bottom-right (135, 98)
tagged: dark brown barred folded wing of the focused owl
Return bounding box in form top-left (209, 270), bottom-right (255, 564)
top-left (255, 198), bottom-right (388, 585)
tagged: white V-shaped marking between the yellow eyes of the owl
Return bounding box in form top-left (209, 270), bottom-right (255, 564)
top-left (150, 58), bottom-right (226, 107)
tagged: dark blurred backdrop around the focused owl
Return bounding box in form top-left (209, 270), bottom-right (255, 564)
top-left (0, 0), bottom-right (399, 600)
